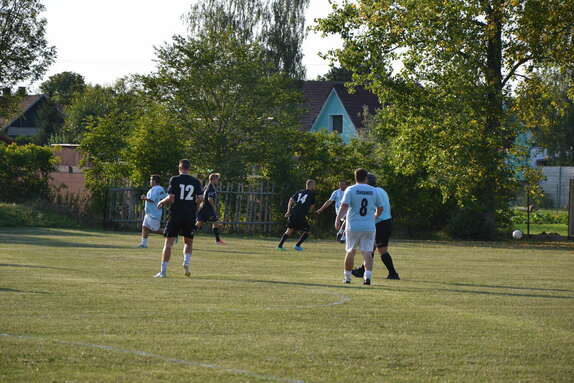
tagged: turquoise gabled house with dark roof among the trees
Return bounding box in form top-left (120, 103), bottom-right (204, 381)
top-left (301, 81), bottom-right (380, 143)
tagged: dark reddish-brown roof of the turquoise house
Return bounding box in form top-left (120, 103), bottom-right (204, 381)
top-left (301, 81), bottom-right (380, 131)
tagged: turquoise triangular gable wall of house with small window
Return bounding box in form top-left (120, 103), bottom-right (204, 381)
top-left (311, 88), bottom-right (357, 143)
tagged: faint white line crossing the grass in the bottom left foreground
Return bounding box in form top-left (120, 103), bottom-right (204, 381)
top-left (0, 333), bottom-right (308, 383)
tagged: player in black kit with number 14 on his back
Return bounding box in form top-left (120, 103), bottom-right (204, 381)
top-left (277, 180), bottom-right (315, 251)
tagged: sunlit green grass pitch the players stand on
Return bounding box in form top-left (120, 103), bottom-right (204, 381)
top-left (0, 229), bottom-right (574, 383)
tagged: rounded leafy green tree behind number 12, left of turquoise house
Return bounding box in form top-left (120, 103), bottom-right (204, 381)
top-left (143, 28), bottom-right (301, 179)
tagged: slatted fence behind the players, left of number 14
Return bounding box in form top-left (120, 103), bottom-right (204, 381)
top-left (104, 182), bottom-right (284, 234)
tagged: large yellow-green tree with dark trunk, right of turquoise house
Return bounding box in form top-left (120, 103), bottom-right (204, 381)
top-left (318, 0), bottom-right (574, 238)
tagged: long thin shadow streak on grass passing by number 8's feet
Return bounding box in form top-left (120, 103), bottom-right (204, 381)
top-left (197, 277), bottom-right (574, 299)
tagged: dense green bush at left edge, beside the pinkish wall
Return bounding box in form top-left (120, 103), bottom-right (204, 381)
top-left (0, 144), bottom-right (56, 202)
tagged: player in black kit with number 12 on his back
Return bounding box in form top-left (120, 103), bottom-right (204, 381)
top-left (155, 160), bottom-right (203, 278)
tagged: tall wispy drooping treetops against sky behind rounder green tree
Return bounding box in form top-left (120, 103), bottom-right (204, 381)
top-left (186, 0), bottom-right (309, 79)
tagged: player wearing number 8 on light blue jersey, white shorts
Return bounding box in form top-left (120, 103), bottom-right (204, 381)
top-left (335, 169), bottom-right (383, 285)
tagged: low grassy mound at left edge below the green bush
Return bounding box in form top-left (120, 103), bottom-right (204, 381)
top-left (0, 200), bottom-right (78, 227)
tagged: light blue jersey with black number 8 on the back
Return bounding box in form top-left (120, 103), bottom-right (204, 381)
top-left (341, 184), bottom-right (383, 232)
